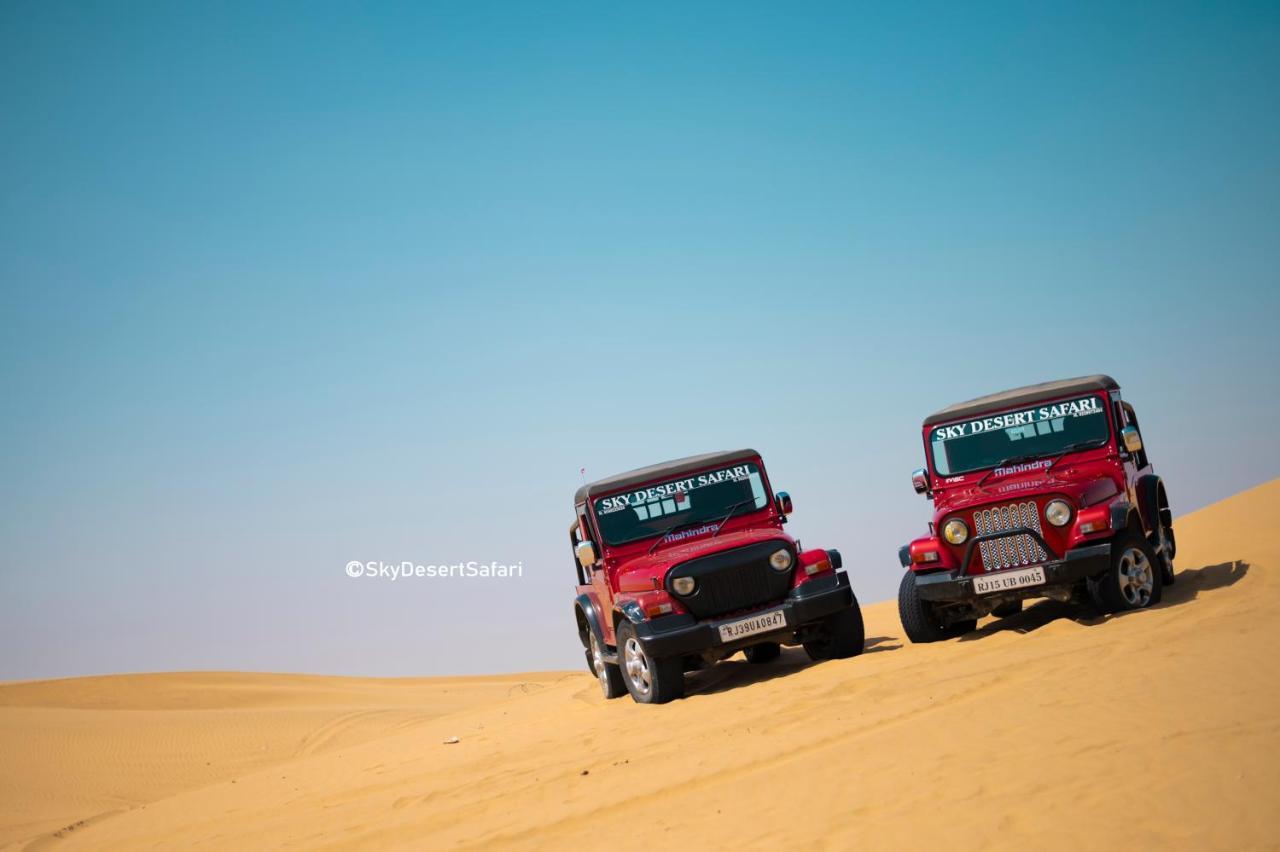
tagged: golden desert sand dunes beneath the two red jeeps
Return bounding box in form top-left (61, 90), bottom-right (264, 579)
top-left (0, 480), bottom-right (1280, 849)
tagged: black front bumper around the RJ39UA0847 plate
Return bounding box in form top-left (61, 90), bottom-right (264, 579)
top-left (636, 572), bottom-right (854, 658)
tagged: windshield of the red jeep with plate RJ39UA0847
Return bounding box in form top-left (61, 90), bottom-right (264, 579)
top-left (595, 462), bottom-right (769, 545)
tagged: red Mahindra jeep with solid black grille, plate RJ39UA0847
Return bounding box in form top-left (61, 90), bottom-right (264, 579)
top-left (570, 449), bottom-right (863, 704)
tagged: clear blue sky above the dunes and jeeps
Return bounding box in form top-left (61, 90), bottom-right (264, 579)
top-left (0, 3), bottom-right (1280, 678)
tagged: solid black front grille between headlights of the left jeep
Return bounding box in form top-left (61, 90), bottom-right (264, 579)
top-left (667, 540), bottom-right (795, 618)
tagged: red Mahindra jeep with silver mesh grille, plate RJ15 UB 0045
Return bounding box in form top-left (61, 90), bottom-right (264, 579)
top-left (897, 376), bottom-right (1175, 642)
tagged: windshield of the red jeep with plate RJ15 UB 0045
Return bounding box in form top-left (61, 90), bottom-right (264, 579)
top-left (929, 397), bottom-right (1110, 476)
